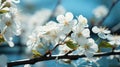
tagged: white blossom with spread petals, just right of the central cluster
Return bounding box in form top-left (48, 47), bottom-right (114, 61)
top-left (92, 26), bottom-right (111, 39)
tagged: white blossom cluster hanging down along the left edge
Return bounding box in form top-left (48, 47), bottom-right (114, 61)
top-left (0, 0), bottom-right (21, 47)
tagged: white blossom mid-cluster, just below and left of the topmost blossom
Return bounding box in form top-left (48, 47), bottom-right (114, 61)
top-left (43, 21), bottom-right (62, 44)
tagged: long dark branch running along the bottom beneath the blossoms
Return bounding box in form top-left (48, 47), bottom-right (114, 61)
top-left (7, 52), bottom-right (120, 67)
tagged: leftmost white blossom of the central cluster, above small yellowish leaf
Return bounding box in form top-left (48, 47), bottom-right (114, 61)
top-left (26, 29), bottom-right (49, 55)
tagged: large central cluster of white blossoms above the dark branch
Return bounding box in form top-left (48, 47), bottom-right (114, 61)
top-left (27, 12), bottom-right (98, 58)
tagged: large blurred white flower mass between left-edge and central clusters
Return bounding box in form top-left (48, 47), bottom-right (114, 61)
top-left (20, 9), bottom-right (51, 44)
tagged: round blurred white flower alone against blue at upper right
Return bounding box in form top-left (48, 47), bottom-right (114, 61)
top-left (93, 5), bottom-right (108, 19)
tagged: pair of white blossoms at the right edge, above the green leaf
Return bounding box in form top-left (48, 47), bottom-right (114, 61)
top-left (92, 26), bottom-right (120, 47)
